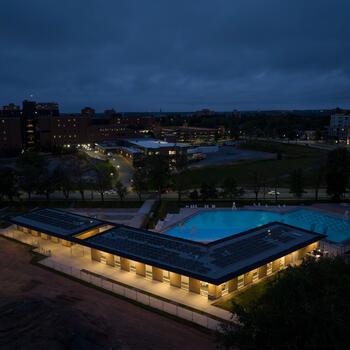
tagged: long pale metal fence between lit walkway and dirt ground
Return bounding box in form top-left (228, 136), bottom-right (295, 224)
top-left (41, 259), bottom-right (220, 330)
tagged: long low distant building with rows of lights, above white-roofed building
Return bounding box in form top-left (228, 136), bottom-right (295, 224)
top-left (152, 123), bottom-right (225, 142)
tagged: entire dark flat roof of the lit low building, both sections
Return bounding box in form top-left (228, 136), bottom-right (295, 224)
top-left (8, 209), bottom-right (326, 285)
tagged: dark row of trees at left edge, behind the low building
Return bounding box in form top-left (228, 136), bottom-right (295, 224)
top-left (0, 152), bottom-right (118, 201)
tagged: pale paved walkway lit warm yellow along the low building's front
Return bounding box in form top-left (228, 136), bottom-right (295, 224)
top-left (0, 230), bottom-right (231, 320)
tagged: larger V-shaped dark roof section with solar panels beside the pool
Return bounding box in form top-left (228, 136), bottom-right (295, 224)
top-left (85, 223), bottom-right (325, 284)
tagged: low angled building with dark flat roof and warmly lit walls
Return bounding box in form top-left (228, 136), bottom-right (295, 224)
top-left (8, 209), bottom-right (326, 299)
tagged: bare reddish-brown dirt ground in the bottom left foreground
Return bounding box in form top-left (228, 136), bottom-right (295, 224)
top-left (0, 237), bottom-right (216, 350)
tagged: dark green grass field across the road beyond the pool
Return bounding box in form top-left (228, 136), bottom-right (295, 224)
top-left (183, 142), bottom-right (327, 188)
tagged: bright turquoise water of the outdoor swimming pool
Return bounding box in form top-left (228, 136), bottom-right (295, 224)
top-left (166, 209), bottom-right (350, 242)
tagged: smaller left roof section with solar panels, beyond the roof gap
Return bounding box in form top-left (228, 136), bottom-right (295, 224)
top-left (9, 209), bottom-right (104, 237)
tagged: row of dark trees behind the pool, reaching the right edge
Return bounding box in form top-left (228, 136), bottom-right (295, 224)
top-left (133, 148), bottom-right (350, 201)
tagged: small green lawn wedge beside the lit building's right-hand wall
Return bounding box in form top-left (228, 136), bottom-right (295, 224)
top-left (213, 275), bottom-right (276, 311)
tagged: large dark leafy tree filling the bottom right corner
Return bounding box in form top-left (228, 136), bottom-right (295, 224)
top-left (218, 257), bottom-right (350, 350)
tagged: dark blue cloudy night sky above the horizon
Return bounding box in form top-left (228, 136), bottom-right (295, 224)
top-left (0, 0), bottom-right (350, 112)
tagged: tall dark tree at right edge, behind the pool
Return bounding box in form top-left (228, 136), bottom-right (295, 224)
top-left (326, 148), bottom-right (350, 201)
